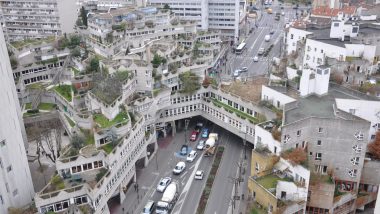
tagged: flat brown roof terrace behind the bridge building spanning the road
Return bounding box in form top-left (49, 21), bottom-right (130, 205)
top-left (221, 77), bottom-right (268, 103)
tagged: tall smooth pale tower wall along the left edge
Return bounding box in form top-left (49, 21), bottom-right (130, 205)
top-left (0, 27), bottom-right (34, 213)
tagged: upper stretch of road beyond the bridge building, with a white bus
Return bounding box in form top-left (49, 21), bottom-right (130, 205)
top-left (220, 2), bottom-right (296, 81)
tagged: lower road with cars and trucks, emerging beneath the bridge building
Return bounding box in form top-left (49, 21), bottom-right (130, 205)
top-left (116, 119), bottom-right (250, 214)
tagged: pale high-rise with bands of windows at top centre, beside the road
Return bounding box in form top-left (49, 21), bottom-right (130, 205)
top-left (148, 0), bottom-right (246, 42)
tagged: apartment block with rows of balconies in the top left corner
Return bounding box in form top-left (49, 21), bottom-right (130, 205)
top-left (0, 0), bottom-right (62, 42)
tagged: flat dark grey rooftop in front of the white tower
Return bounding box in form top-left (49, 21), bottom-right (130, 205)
top-left (284, 84), bottom-right (378, 125)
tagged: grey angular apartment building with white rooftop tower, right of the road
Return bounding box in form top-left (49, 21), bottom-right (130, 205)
top-left (252, 66), bottom-right (380, 213)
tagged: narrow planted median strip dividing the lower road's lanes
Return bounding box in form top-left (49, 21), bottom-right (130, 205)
top-left (197, 146), bottom-right (224, 214)
